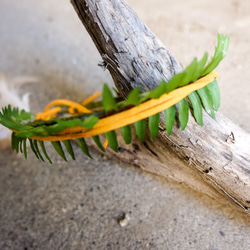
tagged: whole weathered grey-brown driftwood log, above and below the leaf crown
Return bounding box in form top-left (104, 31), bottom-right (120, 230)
top-left (71, 0), bottom-right (250, 214)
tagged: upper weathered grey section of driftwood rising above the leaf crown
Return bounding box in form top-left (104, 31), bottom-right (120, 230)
top-left (72, 0), bottom-right (182, 95)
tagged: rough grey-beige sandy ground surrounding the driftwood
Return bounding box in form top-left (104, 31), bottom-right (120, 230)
top-left (0, 0), bottom-right (250, 250)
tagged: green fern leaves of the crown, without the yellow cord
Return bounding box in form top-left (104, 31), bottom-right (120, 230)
top-left (0, 35), bottom-right (229, 163)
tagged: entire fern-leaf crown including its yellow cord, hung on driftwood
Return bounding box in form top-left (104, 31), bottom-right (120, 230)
top-left (0, 35), bottom-right (229, 163)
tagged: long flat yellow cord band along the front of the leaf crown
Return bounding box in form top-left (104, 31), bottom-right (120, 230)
top-left (31, 71), bottom-right (219, 141)
